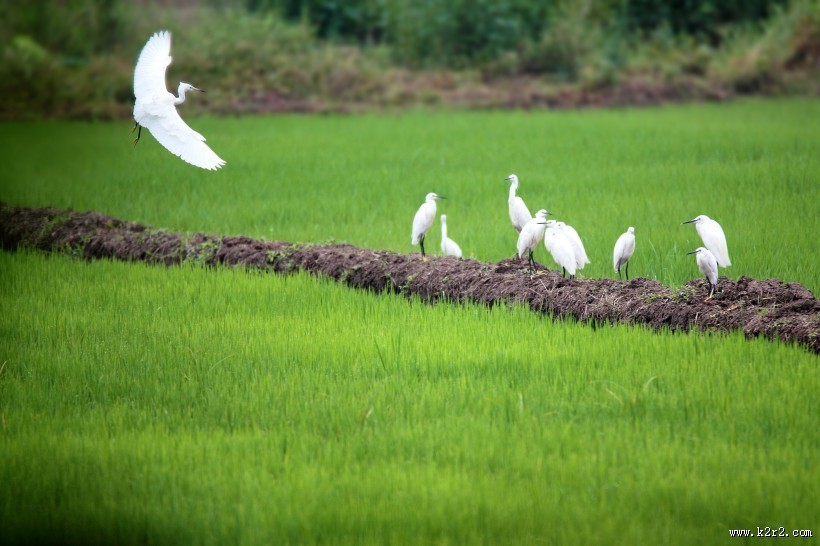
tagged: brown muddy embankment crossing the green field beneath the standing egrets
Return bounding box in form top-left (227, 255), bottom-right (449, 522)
top-left (0, 203), bottom-right (820, 353)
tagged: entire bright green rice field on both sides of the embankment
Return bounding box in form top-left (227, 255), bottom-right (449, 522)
top-left (0, 99), bottom-right (820, 544)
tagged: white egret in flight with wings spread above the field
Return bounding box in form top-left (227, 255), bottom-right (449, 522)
top-left (131, 30), bottom-right (225, 170)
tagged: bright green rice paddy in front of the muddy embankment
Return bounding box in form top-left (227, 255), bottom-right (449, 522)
top-left (0, 253), bottom-right (820, 544)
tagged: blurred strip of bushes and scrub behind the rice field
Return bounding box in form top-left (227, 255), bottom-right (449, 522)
top-left (0, 0), bottom-right (820, 118)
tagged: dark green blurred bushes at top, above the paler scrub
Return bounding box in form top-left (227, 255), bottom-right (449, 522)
top-left (247, 0), bottom-right (788, 66)
